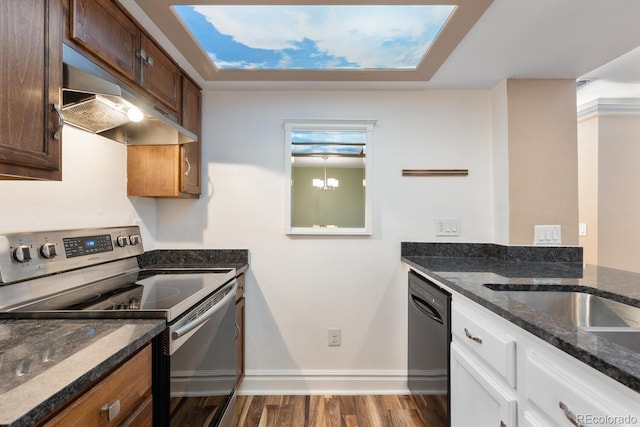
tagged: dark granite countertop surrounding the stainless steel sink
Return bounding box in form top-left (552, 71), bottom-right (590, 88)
top-left (402, 243), bottom-right (640, 392)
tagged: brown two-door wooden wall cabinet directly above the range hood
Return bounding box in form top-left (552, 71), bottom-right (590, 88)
top-left (67, 0), bottom-right (182, 116)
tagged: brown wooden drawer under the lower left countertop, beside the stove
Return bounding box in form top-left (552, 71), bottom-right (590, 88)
top-left (45, 345), bottom-right (151, 427)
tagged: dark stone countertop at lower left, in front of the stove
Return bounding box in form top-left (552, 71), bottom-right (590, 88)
top-left (0, 319), bottom-right (165, 427)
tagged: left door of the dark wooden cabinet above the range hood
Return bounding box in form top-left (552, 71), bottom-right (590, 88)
top-left (69, 0), bottom-right (141, 81)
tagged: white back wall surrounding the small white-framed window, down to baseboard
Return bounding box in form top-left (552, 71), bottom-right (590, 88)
top-left (157, 91), bottom-right (493, 393)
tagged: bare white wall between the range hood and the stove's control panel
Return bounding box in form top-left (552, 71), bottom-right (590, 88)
top-left (0, 126), bottom-right (156, 250)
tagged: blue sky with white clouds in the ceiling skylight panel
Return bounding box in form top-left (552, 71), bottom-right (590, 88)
top-left (173, 5), bottom-right (455, 70)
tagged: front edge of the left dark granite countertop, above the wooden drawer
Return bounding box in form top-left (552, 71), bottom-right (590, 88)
top-left (0, 319), bottom-right (165, 427)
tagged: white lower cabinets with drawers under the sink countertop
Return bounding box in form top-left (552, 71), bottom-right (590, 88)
top-left (451, 292), bottom-right (640, 427)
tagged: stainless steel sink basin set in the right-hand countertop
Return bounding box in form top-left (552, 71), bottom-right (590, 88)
top-left (484, 290), bottom-right (640, 328)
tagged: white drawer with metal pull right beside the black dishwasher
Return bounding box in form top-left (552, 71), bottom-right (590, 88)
top-left (451, 303), bottom-right (516, 388)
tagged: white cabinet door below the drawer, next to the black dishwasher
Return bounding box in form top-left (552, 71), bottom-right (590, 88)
top-left (451, 343), bottom-right (517, 427)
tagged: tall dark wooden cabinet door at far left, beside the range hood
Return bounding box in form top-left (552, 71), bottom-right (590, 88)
top-left (0, 0), bottom-right (62, 180)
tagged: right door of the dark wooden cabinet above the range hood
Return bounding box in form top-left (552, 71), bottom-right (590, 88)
top-left (140, 34), bottom-right (182, 114)
